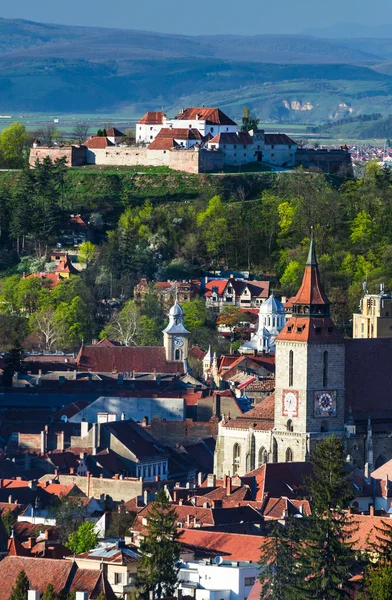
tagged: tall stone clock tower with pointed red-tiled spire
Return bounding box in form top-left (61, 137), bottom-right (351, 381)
top-left (273, 238), bottom-right (344, 462)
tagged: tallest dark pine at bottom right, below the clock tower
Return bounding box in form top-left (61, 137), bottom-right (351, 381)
top-left (299, 436), bottom-right (355, 600)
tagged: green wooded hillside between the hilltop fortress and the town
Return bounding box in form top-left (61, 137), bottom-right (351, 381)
top-left (0, 159), bottom-right (392, 349)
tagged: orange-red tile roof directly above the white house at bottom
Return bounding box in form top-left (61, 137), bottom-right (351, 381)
top-left (178, 529), bottom-right (268, 564)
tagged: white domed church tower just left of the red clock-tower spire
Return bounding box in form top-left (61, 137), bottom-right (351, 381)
top-left (239, 294), bottom-right (285, 354)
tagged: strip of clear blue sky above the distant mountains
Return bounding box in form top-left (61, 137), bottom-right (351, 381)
top-left (0, 0), bottom-right (392, 35)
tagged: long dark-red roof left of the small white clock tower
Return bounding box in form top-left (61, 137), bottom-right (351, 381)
top-left (76, 345), bottom-right (184, 374)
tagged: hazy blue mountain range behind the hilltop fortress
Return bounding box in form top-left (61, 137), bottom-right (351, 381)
top-left (0, 19), bottom-right (392, 122)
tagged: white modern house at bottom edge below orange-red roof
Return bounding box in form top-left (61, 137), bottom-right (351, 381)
top-left (179, 556), bottom-right (261, 600)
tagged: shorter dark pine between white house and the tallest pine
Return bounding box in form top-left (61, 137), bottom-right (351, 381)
top-left (259, 518), bottom-right (302, 600)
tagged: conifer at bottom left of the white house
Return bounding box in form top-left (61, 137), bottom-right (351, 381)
top-left (137, 489), bottom-right (180, 598)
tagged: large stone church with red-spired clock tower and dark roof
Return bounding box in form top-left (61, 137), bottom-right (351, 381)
top-left (214, 240), bottom-right (392, 478)
